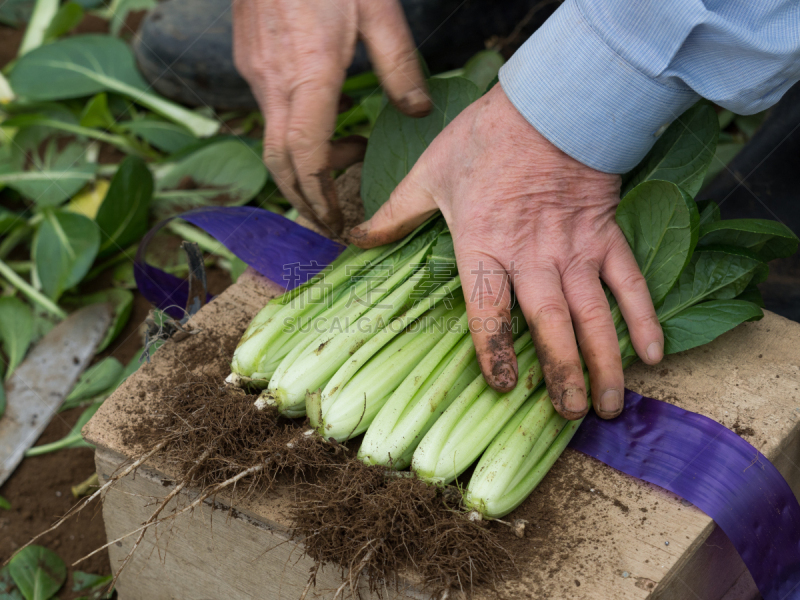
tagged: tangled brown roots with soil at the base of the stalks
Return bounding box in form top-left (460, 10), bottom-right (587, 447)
top-left (116, 375), bottom-right (514, 596)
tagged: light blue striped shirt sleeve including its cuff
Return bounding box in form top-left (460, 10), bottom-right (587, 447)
top-left (500, 0), bottom-right (800, 173)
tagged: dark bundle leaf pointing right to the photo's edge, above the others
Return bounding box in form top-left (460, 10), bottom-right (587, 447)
top-left (698, 219), bottom-right (798, 262)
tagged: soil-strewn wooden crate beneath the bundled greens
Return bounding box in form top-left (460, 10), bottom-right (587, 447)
top-left (84, 178), bottom-right (800, 600)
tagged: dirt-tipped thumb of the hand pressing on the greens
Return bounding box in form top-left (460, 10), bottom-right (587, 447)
top-left (350, 165), bottom-right (438, 248)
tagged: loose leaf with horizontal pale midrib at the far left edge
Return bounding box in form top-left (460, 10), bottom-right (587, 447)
top-left (0, 139), bottom-right (95, 206)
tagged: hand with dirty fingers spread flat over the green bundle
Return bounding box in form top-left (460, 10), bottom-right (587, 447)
top-left (352, 85), bottom-right (664, 419)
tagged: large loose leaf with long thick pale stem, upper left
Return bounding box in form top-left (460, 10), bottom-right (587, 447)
top-left (9, 35), bottom-right (219, 137)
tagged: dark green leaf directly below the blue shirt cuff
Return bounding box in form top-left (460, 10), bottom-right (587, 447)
top-left (622, 102), bottom-right (719, 197)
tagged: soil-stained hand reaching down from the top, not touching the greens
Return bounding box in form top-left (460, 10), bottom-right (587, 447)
top-left (233, 0), bottom-right (431, 234)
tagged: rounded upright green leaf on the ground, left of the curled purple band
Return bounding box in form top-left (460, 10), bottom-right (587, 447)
top-left (33, 211), bottom-right (100, 299)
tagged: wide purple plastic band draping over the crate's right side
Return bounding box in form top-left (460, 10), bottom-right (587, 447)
top-left (570, 390), bottom-right (800, 600)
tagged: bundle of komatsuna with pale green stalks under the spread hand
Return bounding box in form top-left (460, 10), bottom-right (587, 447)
top-left (229, 99), bottom-right (798, 517)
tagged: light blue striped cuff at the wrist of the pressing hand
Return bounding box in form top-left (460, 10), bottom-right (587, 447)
top-left (500, 0), bottom-right (699, 173)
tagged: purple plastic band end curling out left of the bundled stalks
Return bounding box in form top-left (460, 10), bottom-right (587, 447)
top-left (134, 206), bottom-right (344, 318)
